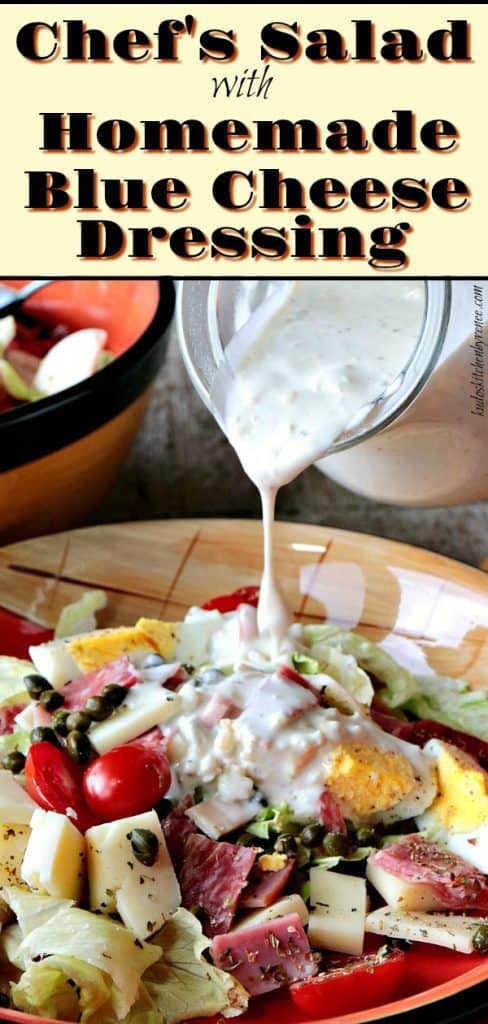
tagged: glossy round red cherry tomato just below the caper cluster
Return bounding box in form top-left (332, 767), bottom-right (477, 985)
top-left (83, 734), bottom-right (171, 821)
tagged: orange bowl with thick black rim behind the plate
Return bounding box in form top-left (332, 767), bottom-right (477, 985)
top-left (0, 279), bottom-right (174, 543)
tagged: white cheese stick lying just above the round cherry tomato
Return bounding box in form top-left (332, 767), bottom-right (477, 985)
top-left (89, 683), bottom-right (180, 754)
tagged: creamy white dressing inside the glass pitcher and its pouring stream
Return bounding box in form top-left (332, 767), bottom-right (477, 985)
top-left (211, 281), bottom-right (425, 656)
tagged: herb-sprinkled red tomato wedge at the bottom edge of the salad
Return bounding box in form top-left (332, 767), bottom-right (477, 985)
top-left (290, 949), bottom-right (407, 1018)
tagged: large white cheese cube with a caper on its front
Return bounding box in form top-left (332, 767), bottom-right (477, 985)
top-left (85, 811), bottom-right (181, 939)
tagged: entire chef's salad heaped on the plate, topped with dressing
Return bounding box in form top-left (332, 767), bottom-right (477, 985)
top-left (0, 588), bottom-right (488, 1024)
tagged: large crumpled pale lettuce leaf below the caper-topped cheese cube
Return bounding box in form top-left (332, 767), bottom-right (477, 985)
top-left (2, 887), bottom-right (161, 1019)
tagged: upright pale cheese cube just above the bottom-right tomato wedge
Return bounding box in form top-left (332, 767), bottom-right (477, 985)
top-left (308, 867), bottom-right (366, 956)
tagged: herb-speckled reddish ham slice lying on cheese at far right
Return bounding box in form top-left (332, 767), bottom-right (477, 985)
top-left (369, 835), bottom-right (488, 912)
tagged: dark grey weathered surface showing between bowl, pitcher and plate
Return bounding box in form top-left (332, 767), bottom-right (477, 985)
top-left (90, 329), bottom-right (488, 565)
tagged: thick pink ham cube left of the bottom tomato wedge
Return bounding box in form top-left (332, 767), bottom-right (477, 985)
top-left (210, 913), bottom-right (317, 991)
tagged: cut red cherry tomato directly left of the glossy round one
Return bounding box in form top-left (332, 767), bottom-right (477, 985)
top-left (26, 742), bottom-right (99, 831)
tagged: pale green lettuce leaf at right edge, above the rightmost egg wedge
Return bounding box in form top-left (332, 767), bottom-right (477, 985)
top-left (405, 676), bottom-right (488, 740)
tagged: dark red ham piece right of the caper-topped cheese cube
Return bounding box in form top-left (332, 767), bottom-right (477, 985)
top-left (178, 835), bottom-right (258, 936)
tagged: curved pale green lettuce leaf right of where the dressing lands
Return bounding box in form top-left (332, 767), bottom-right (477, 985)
top-left (303, 624), bottom-right (418, 709)
